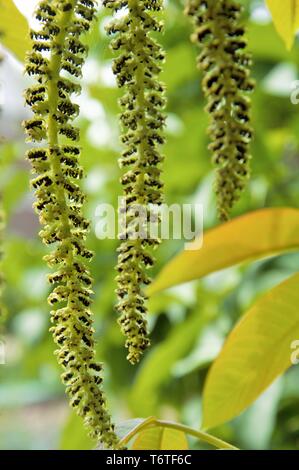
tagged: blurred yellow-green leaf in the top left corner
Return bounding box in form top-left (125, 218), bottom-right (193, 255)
top-left (0, 0), bottom-right (30, 62)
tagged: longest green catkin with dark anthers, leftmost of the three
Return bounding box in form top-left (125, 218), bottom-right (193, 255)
top-left (24, 0), bottom-right (117, 448)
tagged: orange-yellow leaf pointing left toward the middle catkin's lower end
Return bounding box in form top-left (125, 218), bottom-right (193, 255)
top-left (147, 208), bottom-right (299, 295)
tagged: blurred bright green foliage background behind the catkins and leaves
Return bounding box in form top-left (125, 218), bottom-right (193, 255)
top-left (0, 0), bottom-right (299, 449)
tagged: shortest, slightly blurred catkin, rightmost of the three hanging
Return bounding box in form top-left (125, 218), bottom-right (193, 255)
top-left (186, 0), bottom-right (254, 221)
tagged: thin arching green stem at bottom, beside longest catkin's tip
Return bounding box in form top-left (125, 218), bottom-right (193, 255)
top-left (120, 418), bottom-right (239, 450)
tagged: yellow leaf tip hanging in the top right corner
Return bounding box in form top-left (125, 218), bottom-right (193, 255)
top-left (266, 0), bottom-right (299, 49)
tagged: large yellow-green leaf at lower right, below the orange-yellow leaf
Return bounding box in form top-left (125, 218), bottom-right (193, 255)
top-left (203, 274), bottom-right (299, 429)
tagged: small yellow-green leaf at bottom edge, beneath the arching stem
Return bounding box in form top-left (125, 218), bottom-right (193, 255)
top-left (132, 427), bottom-right (189, 450)
